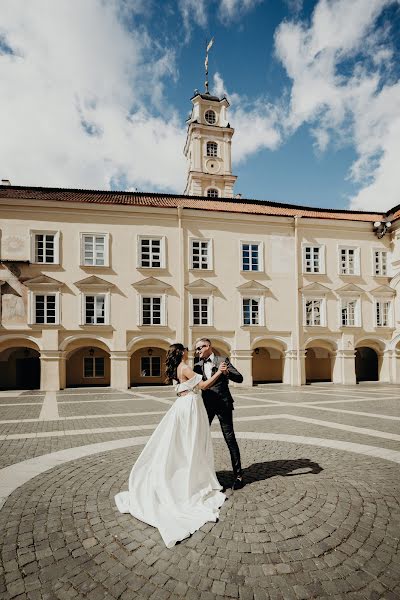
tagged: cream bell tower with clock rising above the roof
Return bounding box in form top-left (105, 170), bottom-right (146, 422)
top-left (184, 90), bottom-right (237, 198)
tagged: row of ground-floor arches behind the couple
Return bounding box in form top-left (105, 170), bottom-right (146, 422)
top-left (0, 335), bottom-right (400, 391)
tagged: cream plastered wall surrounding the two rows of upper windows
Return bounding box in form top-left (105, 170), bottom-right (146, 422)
top-left (0, 199), bottom-right (400, 387)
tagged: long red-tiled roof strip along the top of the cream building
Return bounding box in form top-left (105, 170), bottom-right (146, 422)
top-left (0, 185), bottom-right (394, 222)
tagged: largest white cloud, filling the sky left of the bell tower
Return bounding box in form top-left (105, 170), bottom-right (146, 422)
top-left (0, 0), bottom-right (186, 191)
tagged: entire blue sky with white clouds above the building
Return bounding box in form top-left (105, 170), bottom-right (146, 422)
top-left (0, 0), bottom-right (400, 210)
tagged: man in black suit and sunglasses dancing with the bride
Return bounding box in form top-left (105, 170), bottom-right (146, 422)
top-left (193, 338), bottom-right (244, 490)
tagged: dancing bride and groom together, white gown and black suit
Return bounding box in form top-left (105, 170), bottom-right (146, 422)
top-left (115, 338), bottom-right (243, 548)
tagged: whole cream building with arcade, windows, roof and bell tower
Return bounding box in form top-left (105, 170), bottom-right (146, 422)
top-left (0, 93), bottom-right (400, 391)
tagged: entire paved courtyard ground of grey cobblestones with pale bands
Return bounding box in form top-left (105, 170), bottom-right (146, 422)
top-left (0, 384), bottom-right (400, 600)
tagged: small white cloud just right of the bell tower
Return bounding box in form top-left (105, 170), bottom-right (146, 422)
top-left (213, 73), bottom-right (281, 164)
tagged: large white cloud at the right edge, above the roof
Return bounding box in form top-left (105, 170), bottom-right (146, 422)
top-left (275, 0), bottom-right (400, 210)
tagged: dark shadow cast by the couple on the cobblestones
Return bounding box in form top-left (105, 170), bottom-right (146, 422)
top-left (217, 458), bottom-right (323, 489)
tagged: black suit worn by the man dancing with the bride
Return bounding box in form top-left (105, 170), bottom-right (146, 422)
top-left (194, 355), bottom-right (243, 477)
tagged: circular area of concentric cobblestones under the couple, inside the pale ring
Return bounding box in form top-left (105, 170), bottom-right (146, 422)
top-left (0, 440), bottom-right (400, 600)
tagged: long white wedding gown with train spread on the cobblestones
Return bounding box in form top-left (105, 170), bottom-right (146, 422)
top-left (115, 375), bottom-right (225, 548)
